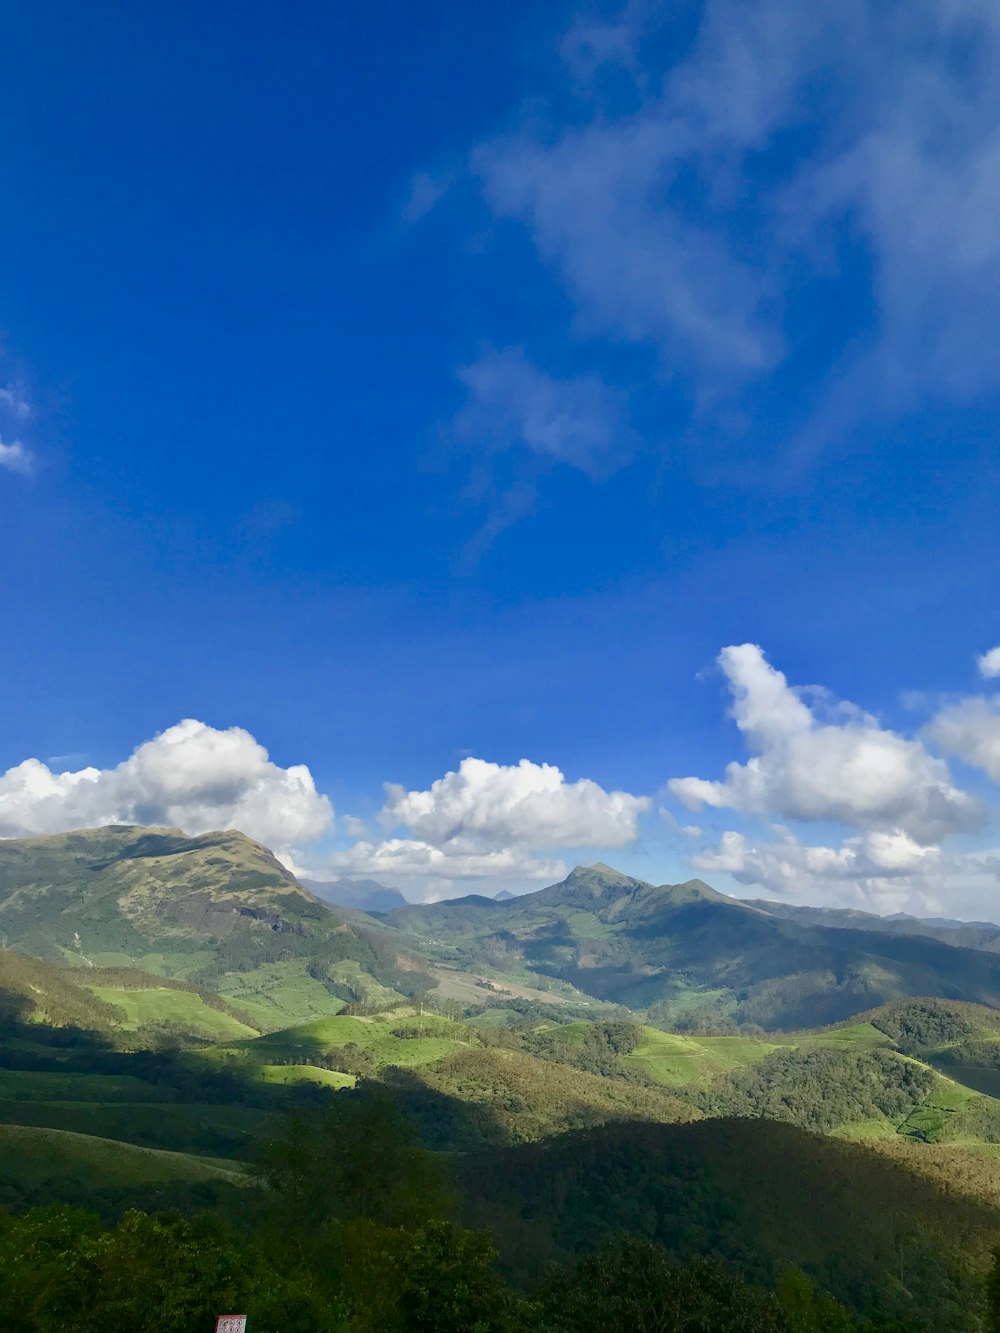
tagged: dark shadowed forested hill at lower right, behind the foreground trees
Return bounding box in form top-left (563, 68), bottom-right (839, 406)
top-left (456, 1120), bottom-right (997, 1329)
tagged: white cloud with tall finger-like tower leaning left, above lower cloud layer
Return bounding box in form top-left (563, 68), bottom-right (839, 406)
top-left (668, 644), bottom-right (979, 846)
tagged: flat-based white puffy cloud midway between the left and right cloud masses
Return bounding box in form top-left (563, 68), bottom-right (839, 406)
top-left (333, 757), bottom-right (651, 880)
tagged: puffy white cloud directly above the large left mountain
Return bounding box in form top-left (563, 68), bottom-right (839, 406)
top-left (0, 718), bottom-right (333, 846)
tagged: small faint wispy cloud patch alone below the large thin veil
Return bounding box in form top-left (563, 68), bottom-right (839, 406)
top-left (455, 348), bottom-right (635, 477)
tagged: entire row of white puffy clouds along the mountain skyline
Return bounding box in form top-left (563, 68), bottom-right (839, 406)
top-left (0, 643), bottom-right (1000, 910)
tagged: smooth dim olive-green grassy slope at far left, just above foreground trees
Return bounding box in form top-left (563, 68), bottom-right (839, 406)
top-left (0, 1125), bottom-right (245, 1189)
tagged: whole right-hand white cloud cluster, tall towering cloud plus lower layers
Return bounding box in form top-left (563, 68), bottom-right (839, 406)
top-left (667, 644), bottom-right (1000, 909)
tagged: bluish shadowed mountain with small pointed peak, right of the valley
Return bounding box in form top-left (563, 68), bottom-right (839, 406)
top-left (379, 864), bottom-right (1000, 1030)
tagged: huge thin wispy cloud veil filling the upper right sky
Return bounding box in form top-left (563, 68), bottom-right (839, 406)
top-left (472, 0), bottom-right (1000, 447)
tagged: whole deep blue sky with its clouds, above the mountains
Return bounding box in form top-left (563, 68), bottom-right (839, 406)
top-left (0, 0), bottom-right (1000, 916)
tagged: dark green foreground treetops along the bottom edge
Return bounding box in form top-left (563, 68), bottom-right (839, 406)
top-left (0, 1097), bottom-right (1000, 1333)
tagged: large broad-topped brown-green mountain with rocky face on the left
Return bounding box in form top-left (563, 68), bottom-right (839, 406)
top-left (0, 826), bottom-right (421, 1018)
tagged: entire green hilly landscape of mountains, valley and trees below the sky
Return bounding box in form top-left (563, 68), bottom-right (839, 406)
top-left (0, 826), bottom-right (1000, 1333)
